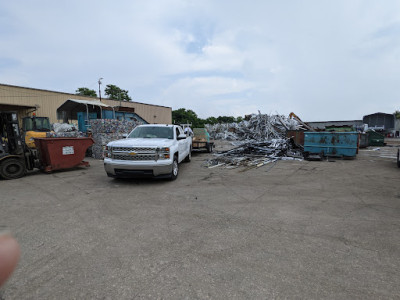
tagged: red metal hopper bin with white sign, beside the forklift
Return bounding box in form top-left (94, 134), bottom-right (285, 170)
top-left (35, 138), bottom-right (94, 173)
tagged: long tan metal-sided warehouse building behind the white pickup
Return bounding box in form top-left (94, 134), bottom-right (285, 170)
top-left (0, 83), bottom-right (172, 124)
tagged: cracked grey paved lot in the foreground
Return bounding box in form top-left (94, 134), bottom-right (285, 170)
top-left (0, 143), bottom-right (400, 299)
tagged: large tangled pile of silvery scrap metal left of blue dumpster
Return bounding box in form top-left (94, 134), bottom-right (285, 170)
top-left (206, 113), bottom-right (305, 168)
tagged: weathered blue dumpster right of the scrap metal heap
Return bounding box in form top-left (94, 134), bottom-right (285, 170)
top-left (304, 131), bottom-right (358, 157)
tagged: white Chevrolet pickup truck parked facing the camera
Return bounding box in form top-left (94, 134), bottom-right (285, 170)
top-left (104, 124), bottom-right (192, 180)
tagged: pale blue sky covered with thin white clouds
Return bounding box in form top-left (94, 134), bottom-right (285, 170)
top-left (0, 0), bottom-right (400, 121)
